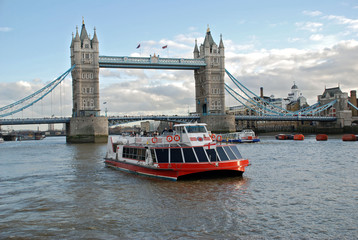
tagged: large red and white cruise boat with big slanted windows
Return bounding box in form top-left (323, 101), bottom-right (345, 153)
top-left (105, 123), bottom-right (249, 180)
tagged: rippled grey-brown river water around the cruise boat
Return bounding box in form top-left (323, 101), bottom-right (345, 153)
top-left (0, 136), bottom-right (358, 239)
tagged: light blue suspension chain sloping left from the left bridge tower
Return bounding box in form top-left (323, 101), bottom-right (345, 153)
top-left (0, 65), bottom-right (75, 117)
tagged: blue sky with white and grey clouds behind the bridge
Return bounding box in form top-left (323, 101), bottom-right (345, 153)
top-left (0, 0), bottom-right (358, 124)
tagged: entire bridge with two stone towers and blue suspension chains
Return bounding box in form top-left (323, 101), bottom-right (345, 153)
top-left (0, 22), bottom-right (356, 142)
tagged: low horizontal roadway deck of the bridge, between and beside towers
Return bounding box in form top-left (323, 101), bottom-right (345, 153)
top-left (0, 115), bottom-right (337, 125)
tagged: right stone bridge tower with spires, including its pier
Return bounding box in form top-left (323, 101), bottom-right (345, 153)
top-left (194, 27), bottom-right (235, 131)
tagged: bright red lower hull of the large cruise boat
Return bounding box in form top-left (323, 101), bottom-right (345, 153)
top-left (105, 159), bottom-right (249, 181)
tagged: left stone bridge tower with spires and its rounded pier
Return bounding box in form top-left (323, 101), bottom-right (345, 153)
top-left (66, 20), bottom-right (108, 142)
